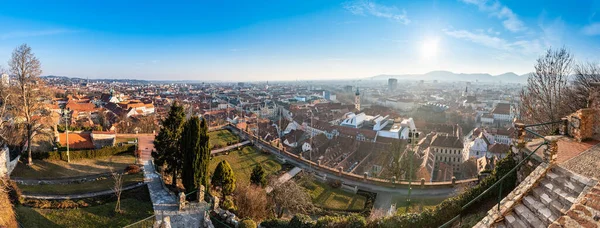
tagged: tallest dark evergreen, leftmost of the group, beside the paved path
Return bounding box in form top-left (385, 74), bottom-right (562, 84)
top-left (152, 102), bottom-right (185, 186)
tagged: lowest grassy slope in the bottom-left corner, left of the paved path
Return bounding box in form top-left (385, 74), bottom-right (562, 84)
top-left (15, 199), bottom-right (154, 228)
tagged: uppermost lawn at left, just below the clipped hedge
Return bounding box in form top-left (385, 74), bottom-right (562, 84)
top-left (11, 153), bottom-right (135, 179)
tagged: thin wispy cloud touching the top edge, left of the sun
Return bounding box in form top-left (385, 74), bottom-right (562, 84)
top-left (344, 1), bottom-right (410, 25)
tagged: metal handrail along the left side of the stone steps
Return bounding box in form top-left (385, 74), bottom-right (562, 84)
top-left (440, 121), bottom-right (563, 228)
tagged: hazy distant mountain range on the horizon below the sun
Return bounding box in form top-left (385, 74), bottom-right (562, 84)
top-left (371, 71), bottom-right (529, 83)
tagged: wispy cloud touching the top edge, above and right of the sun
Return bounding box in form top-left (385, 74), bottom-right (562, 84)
top-left (462, 0), bottom-right (527, 32)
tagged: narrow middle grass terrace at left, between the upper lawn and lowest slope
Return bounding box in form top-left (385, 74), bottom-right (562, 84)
top-left (19, 172), bottom-right (144, 195)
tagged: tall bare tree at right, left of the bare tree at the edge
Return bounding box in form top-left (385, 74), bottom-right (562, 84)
top-left (519, 47), bottom-right (573, 134)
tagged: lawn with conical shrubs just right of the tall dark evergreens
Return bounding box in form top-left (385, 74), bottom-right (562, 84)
top-left (208, 146), bottom-right (281, 183)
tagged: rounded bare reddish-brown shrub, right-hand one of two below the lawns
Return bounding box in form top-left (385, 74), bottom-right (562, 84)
top-left (270, 176), bottom-right (313, 218)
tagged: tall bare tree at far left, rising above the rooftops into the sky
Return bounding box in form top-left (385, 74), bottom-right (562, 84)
top-left (8, 44), bottom-right (48, 165)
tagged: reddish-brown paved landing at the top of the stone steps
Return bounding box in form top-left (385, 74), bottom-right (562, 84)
top-left (560, 144), bottom-right (600, 179)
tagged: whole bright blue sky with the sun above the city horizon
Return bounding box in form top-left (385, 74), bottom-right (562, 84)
top-left (0, 0), bottom-right (600, 81)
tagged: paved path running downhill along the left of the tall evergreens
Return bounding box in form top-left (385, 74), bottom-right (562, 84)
top-left (136, 135), bottom-right (204, 228)
